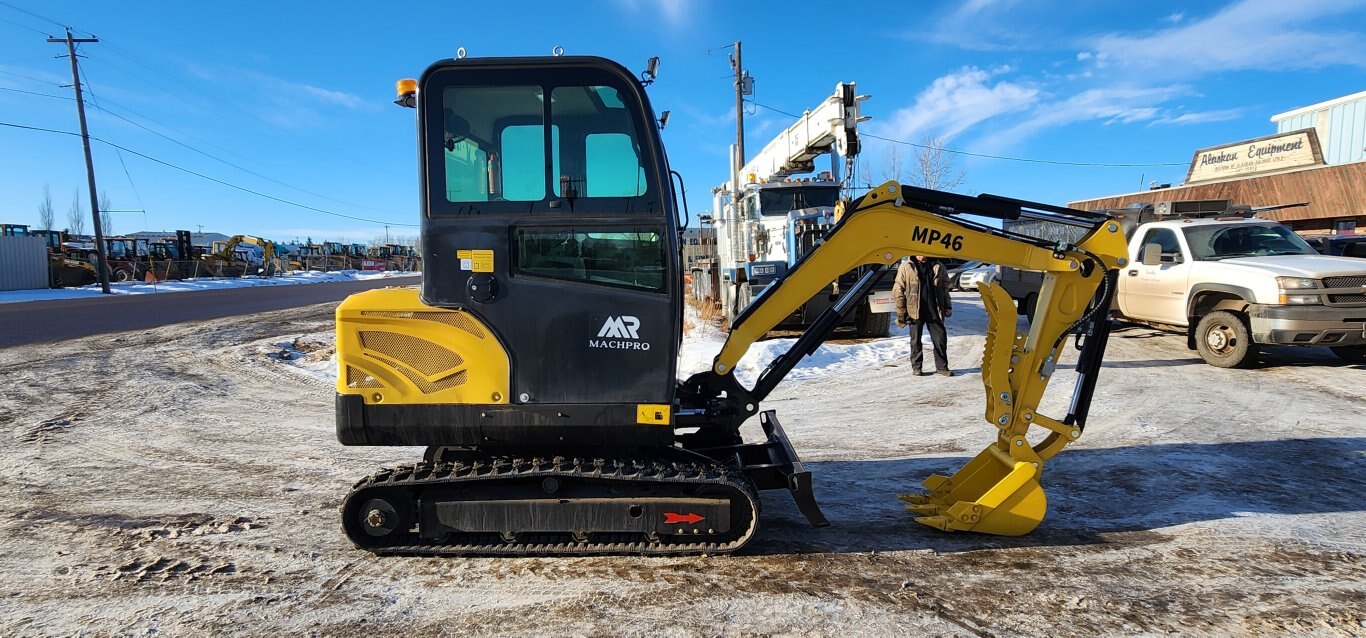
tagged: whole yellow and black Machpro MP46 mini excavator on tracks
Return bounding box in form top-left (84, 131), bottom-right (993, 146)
top-left (336, 56), bottom-right (1124, 555)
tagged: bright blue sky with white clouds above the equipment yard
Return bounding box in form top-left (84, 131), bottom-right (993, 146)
top-left (0, 0), bottom-right (1366, 240)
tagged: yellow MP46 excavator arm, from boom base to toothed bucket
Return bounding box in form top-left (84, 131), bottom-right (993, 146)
top-left (684, 182), bottom-right (1126, 536)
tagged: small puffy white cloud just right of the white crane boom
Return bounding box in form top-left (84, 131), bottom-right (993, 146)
top-left (874, 67), bottom-right (1038, 141)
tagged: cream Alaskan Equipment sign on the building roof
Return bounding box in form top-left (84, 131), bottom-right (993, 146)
top-left (1186, 128), bottom-right (1324, 183)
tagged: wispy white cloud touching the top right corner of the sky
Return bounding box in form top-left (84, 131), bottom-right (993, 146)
top-left (1087, 0), bottom-right (1366, 81)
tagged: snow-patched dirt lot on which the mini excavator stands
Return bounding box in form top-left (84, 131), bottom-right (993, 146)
top-left (0, 295), bottom-right (1366, 637)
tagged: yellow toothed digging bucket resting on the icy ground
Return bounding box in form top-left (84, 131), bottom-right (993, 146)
top-left (897, 444), bottom-right (1048, 536)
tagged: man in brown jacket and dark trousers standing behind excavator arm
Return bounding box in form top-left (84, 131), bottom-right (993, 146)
top-left (892, 255), bottom-right (953, 377)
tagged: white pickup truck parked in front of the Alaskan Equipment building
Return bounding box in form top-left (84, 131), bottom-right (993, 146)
top-left (1116, 217), bottom-right (1366, 367)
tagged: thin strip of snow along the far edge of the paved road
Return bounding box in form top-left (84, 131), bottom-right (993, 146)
top-left (0, 271), bottom-right (421, 303)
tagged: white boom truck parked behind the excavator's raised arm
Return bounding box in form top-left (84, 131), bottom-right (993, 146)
top-left (712, 82), bottom-right (896, 337)
